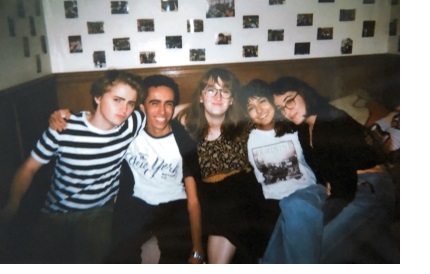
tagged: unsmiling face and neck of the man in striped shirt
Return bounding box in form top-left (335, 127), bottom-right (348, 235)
top-left (90, 82), bottom-right (137, 130)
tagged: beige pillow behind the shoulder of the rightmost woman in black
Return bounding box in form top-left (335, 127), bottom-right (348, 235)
top-left (330, 94), bottom-right (369, 125)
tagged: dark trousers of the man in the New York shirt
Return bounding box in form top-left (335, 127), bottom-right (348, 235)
top-left (106, 197), bottom-right (192, 263)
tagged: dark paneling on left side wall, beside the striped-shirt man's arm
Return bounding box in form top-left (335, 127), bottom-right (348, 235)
top-left (0, 75), bottom-right (58, 206)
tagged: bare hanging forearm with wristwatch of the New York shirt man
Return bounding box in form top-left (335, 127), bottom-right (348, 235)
top-left (185, 176), bottom-right (203, 263)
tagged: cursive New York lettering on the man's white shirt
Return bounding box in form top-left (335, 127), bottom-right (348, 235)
top-left (126, 153), bottom-right (179, 180)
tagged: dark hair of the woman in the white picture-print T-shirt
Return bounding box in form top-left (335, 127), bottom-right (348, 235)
top-left (237, 79), bottom-right (294, 137)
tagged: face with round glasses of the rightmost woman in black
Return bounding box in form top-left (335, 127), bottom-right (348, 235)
top-left (273, 91), bottom-right (306, 125)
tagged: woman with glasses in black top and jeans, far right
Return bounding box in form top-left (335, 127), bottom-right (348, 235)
top-left (265, 77), bottom-right (400, 263)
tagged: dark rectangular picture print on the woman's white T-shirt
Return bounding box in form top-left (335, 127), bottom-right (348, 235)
top-left (252, 141), bottom-right (303, 185)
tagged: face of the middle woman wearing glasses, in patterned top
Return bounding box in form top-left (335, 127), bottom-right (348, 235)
top-left (200, 78), bottom-right (233, 120)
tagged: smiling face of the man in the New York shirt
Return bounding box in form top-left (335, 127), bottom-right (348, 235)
top-left (140, 86), bottom-right (175, 137)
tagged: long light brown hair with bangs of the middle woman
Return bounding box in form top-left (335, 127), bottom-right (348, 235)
top-left (178, 67), bottom-right (249, 141)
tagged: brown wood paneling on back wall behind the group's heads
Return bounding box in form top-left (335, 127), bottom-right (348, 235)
top-left (56, 54), bottom-right (400, 111)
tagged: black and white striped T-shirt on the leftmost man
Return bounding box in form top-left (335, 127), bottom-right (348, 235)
top-left (31, 111), bottom-right (145, 213)
